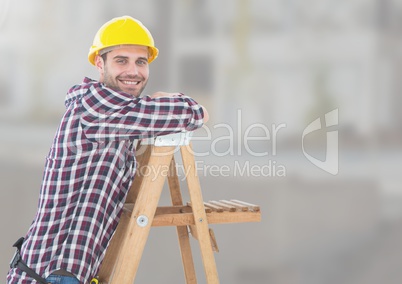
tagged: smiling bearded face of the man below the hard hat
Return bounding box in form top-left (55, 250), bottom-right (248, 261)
top-left (96, 45), bottom-right (149, 97)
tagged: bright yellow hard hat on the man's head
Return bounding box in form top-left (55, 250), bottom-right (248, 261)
top-left (88, 16), bottom-right (159, 65)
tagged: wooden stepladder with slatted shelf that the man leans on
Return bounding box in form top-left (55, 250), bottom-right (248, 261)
top-left (99, 132), bottom-right (261, 284)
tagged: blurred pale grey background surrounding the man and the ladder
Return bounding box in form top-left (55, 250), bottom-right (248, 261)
top-left (0, 0), bottom-right (402, 284)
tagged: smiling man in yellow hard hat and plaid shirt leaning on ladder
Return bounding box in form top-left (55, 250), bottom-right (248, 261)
top-left (7, 16), bottom-right (208, 283)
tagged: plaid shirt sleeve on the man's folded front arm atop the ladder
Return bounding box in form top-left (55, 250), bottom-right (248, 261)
top-left (80, 83), bottom-right (204, 140)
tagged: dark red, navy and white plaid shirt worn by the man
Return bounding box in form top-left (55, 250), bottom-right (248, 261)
top-left (7, 78), bottom-right (203, 283)
